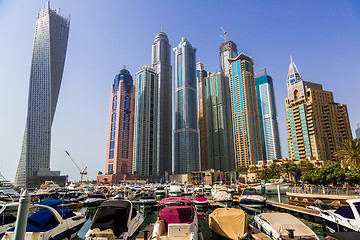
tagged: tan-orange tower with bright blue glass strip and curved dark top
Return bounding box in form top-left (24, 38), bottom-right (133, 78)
top-left (229, 53), bottom-right (263, 167)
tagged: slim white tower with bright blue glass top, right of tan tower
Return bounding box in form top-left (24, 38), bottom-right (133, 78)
top-left (255, 68), bottom-right (281, 160)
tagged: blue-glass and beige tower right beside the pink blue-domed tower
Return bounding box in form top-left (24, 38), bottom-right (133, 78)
top-left (133, 65), bottom-right (160, 176)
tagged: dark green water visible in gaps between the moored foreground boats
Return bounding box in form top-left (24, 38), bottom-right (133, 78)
top-left (77, 195), bottom-right (324, 239)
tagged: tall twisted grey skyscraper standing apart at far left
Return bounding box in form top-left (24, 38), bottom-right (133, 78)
top-left (14, 2), bottom-right (70, 187)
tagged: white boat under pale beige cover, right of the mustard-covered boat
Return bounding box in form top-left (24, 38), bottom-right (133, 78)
top-left (254, 212), bottom-right (319, 240)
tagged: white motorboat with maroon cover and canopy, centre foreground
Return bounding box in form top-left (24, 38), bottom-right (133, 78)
top-left (151, 197), bottom-right (199, 240)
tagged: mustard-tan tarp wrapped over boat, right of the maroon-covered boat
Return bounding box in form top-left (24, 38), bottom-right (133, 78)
top-left (209, 208), bottom-right (248, 240)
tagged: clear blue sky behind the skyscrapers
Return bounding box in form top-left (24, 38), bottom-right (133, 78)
top-left (0, 0), bottom-right (360, 181)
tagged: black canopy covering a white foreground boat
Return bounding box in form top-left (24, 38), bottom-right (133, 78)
top-left (90, 200), bottom-right (131, 237)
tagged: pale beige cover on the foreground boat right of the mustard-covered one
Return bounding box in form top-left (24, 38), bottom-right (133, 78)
top-left (261, 213), bottom-right (316, 239)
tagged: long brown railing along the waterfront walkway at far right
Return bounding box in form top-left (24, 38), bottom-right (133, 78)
top-left (287, 186), bottom-right (360, 195)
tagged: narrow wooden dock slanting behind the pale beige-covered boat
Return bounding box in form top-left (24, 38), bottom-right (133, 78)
top-left (266, 200), bottom-right (322, 223)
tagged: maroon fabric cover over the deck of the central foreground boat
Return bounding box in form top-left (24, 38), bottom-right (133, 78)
top-left (159, 206), bottom-right (193, 224)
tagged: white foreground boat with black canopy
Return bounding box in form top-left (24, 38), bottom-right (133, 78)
top-left (85, 200), bottom-right (144, 240)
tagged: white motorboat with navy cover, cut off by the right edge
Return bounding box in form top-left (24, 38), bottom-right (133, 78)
top-left (319, 199), bottom-right (360, 233)
